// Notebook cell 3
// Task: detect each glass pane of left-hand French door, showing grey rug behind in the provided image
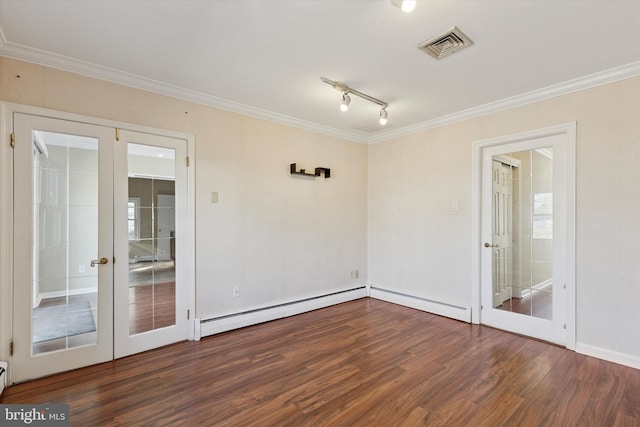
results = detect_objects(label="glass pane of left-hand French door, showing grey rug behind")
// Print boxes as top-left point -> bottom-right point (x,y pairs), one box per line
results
31,130 -> 99,354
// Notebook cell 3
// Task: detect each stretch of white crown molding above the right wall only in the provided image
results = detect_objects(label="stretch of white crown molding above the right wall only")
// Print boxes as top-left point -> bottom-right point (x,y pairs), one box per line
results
367,61 -> 640,144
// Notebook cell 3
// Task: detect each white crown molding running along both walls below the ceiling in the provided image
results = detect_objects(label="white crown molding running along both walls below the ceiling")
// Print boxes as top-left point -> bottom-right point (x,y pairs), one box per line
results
0,27 -> 640,144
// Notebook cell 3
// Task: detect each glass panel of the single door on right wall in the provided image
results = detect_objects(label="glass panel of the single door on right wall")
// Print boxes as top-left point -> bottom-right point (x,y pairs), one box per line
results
492,147 -> 553,320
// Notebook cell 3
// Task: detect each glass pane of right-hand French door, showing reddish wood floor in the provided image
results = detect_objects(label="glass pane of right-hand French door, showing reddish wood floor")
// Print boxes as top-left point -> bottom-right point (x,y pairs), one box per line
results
127,143 -> 176,335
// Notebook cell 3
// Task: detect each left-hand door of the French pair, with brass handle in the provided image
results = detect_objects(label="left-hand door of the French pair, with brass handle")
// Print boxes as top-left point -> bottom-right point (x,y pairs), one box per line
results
11,113 -> 114,382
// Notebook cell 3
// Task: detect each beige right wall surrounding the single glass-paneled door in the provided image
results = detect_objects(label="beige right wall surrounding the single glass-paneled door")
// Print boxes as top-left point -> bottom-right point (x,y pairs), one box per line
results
368,78 -> 640,364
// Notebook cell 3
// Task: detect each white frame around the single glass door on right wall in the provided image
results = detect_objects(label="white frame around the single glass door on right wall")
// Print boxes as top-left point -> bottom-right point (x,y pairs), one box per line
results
471,122 -> 576,350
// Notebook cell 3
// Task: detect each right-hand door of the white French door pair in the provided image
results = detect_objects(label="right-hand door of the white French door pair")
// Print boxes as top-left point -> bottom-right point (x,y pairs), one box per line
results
114,131 -> 189,358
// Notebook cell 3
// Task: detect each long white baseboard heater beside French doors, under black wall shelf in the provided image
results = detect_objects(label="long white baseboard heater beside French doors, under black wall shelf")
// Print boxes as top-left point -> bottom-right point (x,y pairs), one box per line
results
195,286 -> 367,340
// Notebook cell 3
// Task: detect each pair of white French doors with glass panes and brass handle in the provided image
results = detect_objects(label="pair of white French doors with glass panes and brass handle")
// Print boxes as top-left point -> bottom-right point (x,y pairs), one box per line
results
11,113 -> 188,382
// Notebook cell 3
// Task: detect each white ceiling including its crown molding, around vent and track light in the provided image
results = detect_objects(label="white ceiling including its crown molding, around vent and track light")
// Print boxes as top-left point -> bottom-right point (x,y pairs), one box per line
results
0,0 -> 640,142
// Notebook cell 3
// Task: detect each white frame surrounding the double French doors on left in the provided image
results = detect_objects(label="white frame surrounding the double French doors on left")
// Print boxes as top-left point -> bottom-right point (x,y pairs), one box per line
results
0,101 -> 196,380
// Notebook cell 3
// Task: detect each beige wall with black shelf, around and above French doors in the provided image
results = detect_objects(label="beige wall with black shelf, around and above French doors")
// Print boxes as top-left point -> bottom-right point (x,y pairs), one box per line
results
0,57 -> 367,318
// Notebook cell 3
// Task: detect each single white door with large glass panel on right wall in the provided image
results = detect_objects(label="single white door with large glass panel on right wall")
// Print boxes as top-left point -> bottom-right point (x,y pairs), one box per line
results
480,135 -> 569,345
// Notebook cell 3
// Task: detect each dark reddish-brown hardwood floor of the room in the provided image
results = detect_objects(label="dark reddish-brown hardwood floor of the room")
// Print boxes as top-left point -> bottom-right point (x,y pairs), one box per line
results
2,298 -> 640,427
